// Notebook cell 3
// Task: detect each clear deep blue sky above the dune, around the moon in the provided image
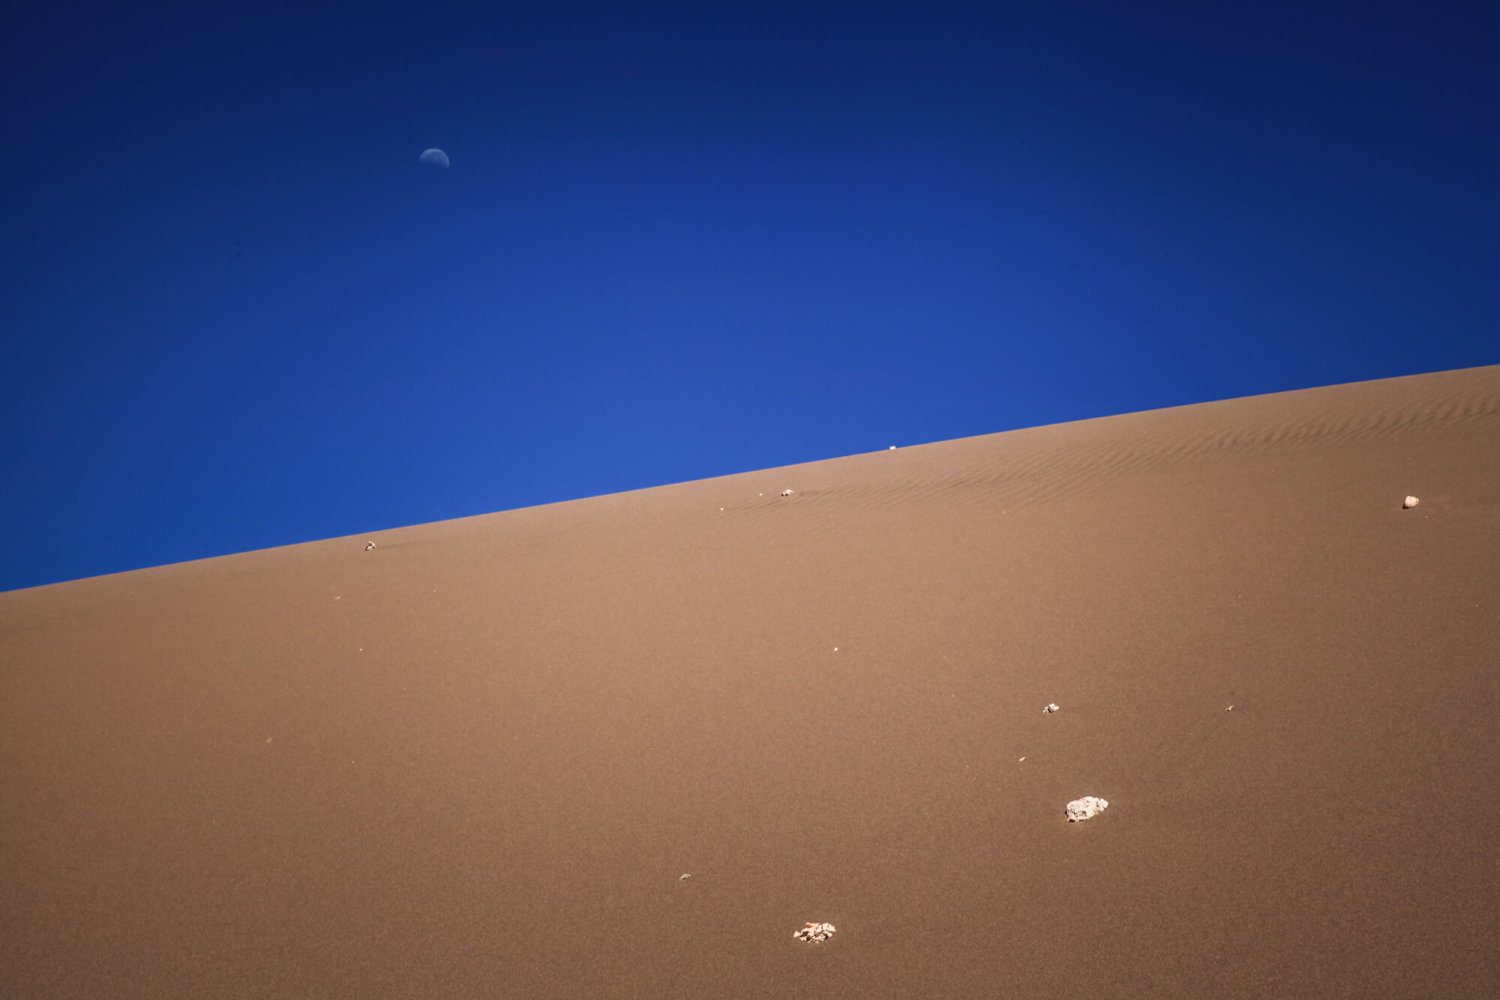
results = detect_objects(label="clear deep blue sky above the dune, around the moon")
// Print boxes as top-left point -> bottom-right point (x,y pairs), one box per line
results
0,0 -> 1500,589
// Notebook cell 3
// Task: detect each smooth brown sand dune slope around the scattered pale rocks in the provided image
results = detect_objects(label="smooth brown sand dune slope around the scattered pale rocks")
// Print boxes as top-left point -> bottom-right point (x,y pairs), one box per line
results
0,367 -> 1500,1000
